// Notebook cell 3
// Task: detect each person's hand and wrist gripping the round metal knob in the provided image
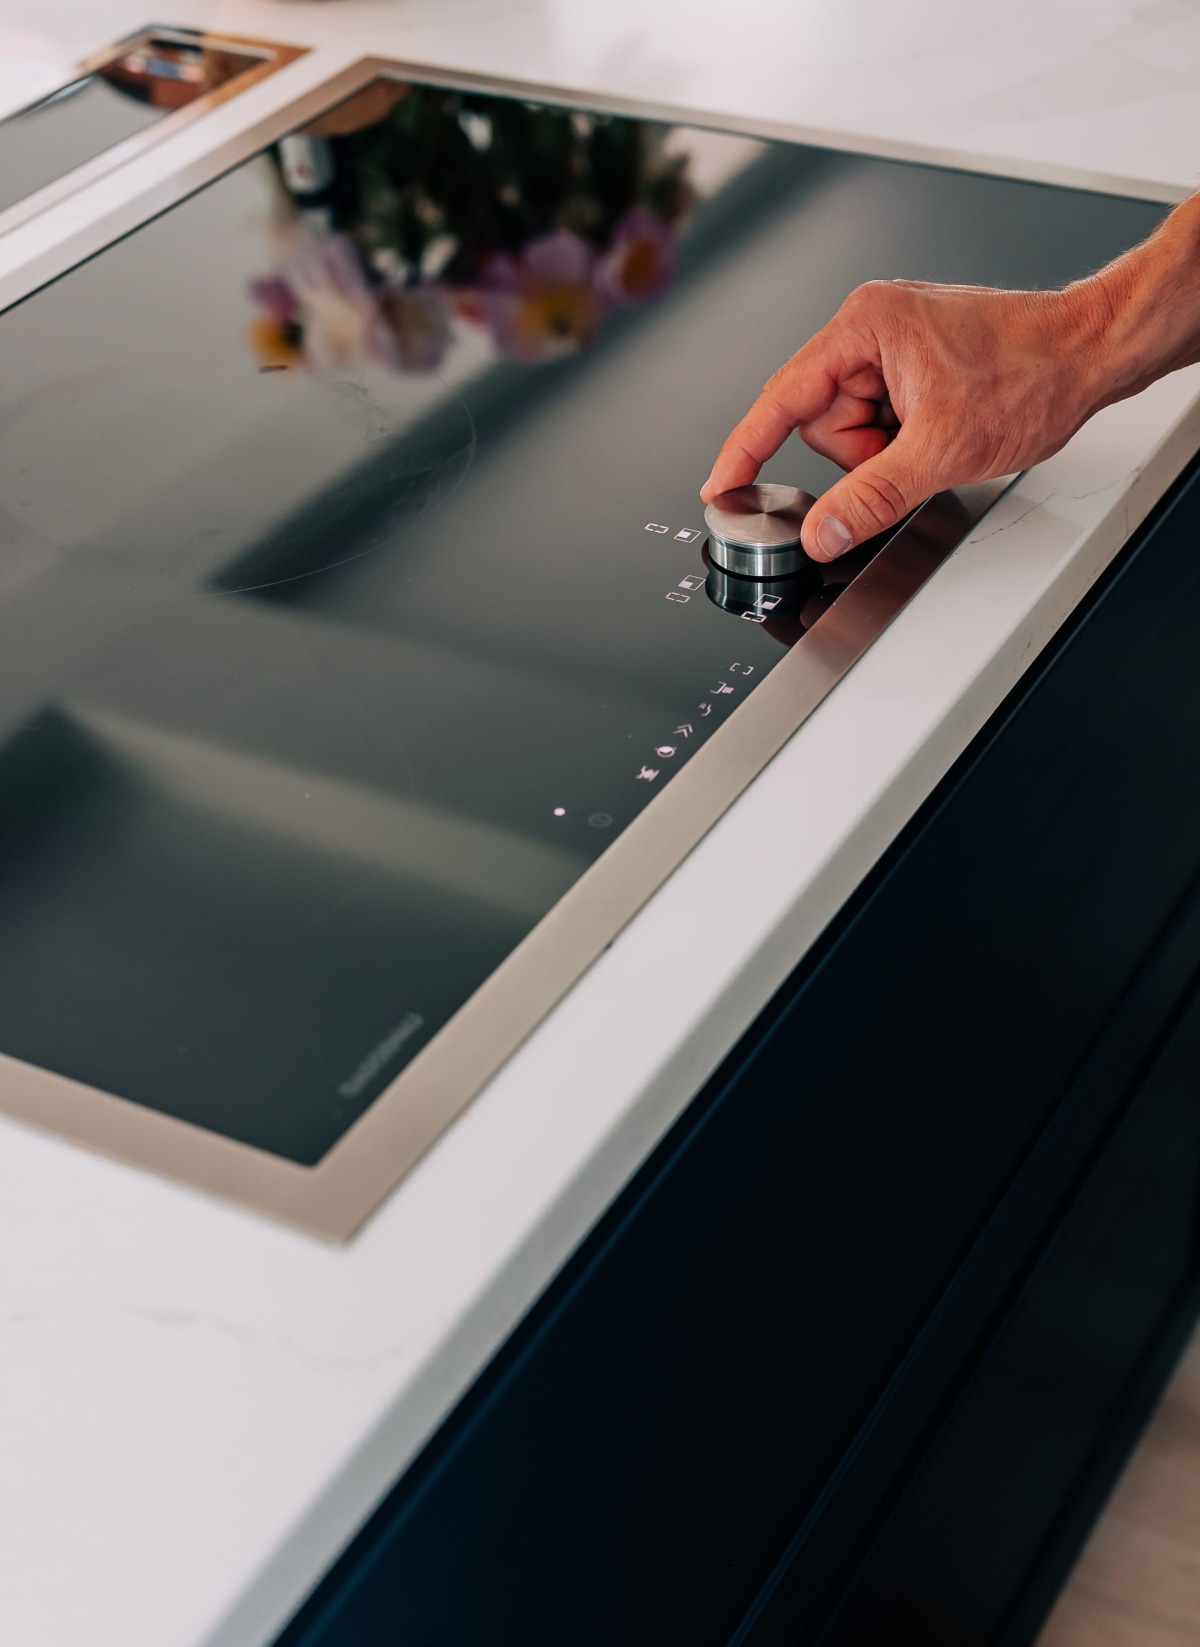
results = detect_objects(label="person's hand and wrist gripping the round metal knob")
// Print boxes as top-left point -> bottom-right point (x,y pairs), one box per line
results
700,196 -> 1200,560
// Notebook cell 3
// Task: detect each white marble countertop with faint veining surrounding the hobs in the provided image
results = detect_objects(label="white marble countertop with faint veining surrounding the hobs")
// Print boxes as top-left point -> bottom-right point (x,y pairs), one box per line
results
0,0 -> 1200,1647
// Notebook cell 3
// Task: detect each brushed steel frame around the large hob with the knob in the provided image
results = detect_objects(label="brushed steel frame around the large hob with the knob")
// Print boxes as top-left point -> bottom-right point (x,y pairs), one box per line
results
0,59 -> 1014,1240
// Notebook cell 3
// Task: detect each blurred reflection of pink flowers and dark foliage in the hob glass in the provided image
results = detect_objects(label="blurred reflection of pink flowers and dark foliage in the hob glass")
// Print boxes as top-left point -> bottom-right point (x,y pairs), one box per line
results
252,81 -> 695,372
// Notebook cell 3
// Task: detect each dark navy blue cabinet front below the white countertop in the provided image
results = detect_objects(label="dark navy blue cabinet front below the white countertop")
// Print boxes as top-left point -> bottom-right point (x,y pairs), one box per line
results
280,454 -> 1200,1647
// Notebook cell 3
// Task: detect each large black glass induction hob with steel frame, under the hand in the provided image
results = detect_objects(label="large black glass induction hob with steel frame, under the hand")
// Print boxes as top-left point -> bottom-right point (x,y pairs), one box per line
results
0,63 -> 1162,1237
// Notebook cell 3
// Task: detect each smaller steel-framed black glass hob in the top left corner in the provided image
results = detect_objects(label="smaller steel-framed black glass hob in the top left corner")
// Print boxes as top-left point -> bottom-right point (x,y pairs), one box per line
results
0,28 -> 303,232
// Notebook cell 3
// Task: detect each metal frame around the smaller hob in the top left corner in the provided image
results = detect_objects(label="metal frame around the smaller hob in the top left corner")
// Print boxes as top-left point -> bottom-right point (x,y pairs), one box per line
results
0,28 -> 309,236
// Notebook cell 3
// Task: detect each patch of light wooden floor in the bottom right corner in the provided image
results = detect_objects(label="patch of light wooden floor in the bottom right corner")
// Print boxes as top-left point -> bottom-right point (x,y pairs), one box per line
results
1037,1332 -> 1200,1647
